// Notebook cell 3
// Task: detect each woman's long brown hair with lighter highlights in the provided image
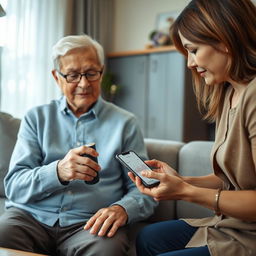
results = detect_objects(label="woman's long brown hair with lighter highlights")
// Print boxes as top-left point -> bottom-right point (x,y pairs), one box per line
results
171,0 -> 256,120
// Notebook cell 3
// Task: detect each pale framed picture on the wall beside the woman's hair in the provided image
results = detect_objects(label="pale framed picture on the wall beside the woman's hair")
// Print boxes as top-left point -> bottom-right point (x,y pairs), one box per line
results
156,11 -> 180,33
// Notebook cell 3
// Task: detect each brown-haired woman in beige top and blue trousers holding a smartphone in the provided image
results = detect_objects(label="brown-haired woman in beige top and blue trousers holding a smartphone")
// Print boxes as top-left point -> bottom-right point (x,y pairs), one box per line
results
129,0 -> 256,256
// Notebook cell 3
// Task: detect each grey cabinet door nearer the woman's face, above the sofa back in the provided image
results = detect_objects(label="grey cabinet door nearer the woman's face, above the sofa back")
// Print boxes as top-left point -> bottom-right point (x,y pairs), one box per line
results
147,52 -> 185,141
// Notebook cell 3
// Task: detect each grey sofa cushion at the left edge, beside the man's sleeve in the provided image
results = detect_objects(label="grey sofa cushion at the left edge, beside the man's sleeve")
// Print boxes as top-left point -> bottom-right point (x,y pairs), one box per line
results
0,112 -> 20,196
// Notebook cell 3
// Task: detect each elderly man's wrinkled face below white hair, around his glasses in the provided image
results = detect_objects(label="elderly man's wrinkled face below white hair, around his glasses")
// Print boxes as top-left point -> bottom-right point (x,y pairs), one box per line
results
53,47 -> 103,117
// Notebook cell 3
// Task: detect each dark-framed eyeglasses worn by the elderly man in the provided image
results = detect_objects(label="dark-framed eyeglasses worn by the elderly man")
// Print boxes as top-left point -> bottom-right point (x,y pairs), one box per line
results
57,70 -> 102,83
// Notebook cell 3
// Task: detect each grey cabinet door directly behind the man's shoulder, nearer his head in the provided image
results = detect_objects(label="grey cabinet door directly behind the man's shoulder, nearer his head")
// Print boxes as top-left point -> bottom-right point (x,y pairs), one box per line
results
108,55 -> 148,136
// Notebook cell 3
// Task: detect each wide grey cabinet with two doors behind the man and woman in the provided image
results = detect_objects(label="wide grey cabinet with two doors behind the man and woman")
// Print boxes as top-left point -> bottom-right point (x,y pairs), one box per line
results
107,50 -> 209,142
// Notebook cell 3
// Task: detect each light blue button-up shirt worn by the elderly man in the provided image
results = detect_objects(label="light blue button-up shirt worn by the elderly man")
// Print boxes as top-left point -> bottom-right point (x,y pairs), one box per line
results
4,97 -> 157,226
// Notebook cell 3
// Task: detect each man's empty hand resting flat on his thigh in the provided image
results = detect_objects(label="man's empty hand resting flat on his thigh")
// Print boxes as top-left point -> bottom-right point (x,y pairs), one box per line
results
84,205 -> 128,237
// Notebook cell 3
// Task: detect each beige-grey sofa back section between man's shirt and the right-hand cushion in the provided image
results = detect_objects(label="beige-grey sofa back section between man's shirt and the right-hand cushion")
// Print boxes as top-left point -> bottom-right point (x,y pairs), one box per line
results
144,138 -> 184,222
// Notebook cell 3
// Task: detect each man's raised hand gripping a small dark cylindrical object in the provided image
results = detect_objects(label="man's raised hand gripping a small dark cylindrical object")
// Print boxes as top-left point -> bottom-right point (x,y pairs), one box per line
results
57,146 -> 101,182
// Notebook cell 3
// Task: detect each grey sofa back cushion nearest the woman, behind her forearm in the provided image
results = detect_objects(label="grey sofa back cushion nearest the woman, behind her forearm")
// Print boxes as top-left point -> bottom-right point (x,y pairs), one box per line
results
177,141 -> 213,218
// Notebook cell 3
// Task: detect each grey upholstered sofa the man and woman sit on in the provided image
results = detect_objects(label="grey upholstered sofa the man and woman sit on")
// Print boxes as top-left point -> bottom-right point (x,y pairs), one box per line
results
0,112 -> 213,256
